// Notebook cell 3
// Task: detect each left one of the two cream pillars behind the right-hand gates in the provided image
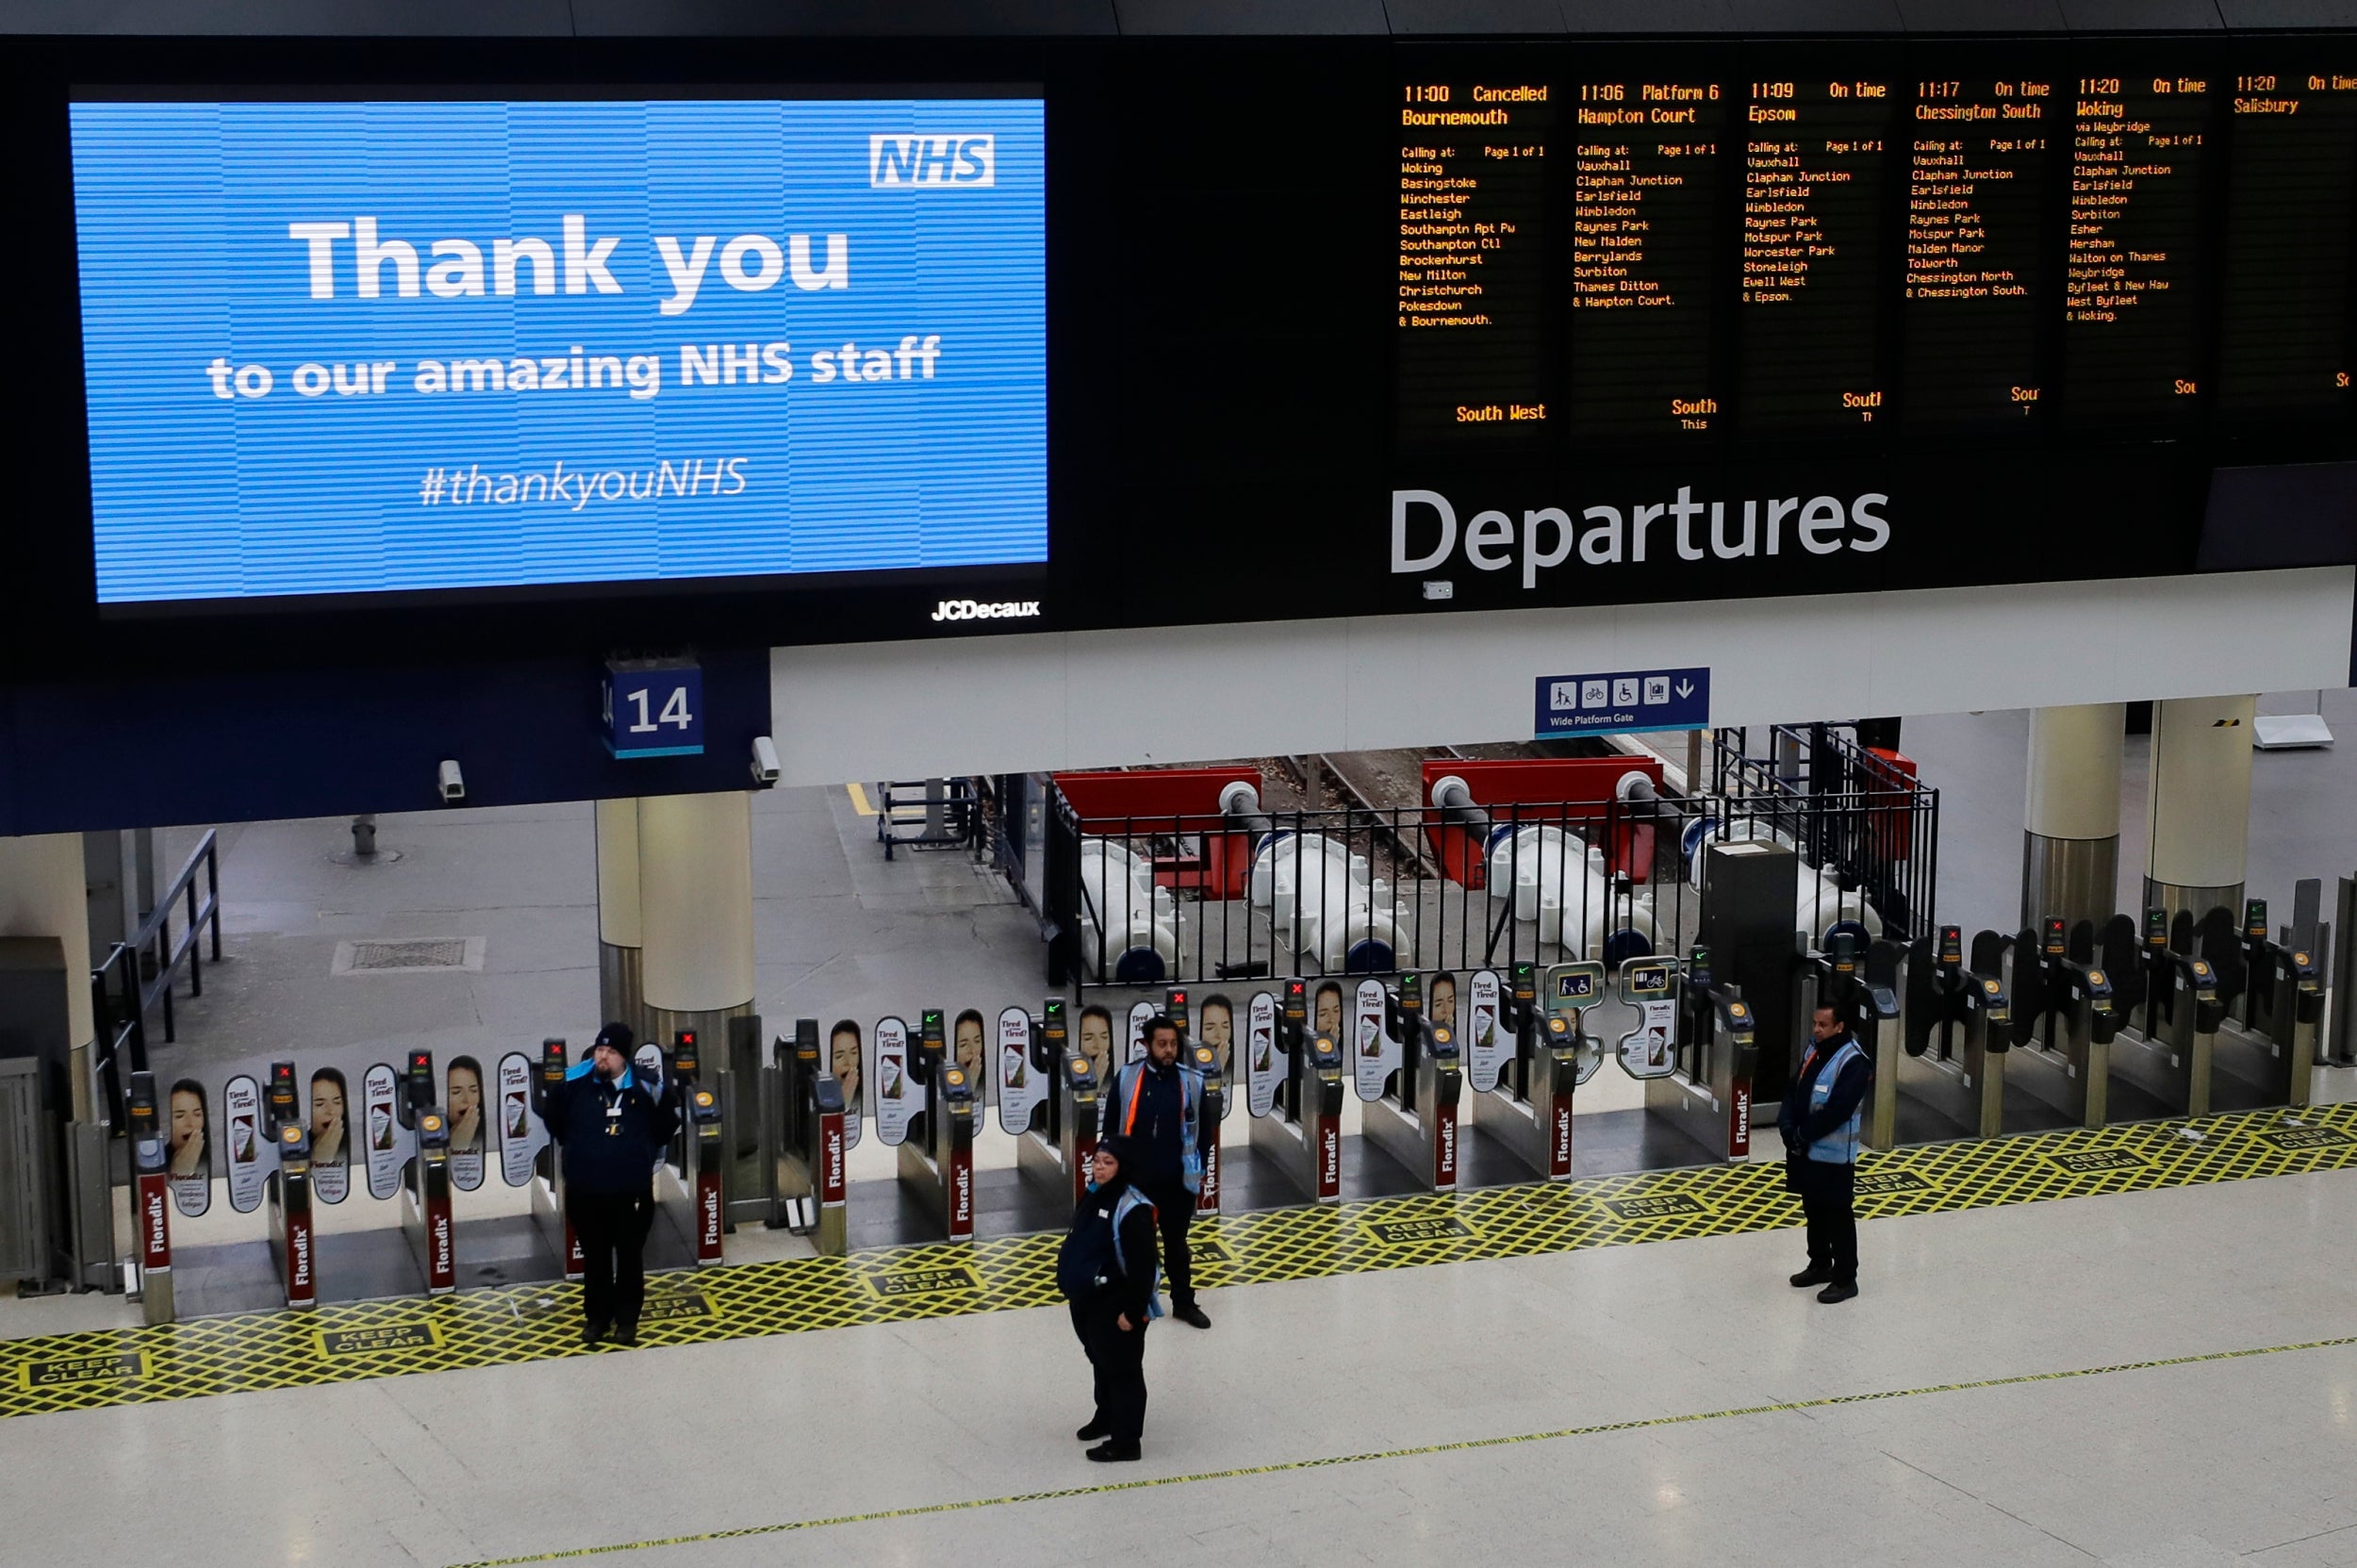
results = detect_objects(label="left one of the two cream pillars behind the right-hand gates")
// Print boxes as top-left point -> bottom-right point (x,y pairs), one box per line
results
2022,702 -> 2129,929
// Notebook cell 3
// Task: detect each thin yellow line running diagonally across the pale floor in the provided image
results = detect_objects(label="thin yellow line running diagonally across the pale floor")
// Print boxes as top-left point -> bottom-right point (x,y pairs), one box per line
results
438,1334 -> 2357,1568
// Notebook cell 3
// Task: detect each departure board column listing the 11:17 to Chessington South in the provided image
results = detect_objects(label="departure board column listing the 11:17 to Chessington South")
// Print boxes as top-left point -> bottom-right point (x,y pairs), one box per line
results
1900,75 -> 2063,429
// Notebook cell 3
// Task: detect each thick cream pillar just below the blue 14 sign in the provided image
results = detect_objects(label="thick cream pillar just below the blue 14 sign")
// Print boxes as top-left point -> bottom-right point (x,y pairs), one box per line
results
639,792 -> 752,1061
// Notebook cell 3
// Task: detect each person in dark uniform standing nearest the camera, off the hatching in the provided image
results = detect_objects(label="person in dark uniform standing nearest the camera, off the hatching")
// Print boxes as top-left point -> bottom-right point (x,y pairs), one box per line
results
1056,1136 -> 1162,1464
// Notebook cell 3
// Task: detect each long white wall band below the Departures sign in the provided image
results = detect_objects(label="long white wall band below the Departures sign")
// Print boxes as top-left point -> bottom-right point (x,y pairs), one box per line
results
771,566 -> 2357,783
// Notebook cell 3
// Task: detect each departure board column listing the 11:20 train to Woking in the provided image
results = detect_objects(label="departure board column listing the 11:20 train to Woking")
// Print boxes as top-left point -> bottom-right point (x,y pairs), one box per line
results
2063,74 -> 2211,429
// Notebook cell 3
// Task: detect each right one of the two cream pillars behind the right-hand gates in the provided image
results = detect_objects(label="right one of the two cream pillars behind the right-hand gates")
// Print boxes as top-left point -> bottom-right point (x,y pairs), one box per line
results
2145,698 -> 2258,924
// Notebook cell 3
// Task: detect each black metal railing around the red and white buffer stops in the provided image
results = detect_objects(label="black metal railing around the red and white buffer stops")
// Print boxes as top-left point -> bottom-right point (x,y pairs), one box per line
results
1045,787 -> 1937,990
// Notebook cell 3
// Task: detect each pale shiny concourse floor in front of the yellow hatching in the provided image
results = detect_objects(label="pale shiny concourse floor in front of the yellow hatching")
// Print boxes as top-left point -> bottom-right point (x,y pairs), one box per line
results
13,1172 -> 2357,1568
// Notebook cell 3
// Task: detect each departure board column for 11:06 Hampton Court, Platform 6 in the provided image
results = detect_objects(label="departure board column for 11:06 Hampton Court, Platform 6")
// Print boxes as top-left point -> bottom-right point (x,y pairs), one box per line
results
1570,80 -> 1730,438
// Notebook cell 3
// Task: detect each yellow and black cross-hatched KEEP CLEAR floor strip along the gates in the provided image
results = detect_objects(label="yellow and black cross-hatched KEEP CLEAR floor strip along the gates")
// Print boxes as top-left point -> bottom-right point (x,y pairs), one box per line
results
0,1103 -> 2357,1414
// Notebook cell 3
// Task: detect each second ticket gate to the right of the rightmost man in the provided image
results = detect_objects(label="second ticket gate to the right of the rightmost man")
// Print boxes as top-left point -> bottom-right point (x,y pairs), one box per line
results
1973,917 -> 2131,1127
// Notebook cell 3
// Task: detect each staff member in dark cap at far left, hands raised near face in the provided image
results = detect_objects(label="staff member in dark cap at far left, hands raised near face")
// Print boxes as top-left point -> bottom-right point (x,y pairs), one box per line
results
547,1023 -> 679,1344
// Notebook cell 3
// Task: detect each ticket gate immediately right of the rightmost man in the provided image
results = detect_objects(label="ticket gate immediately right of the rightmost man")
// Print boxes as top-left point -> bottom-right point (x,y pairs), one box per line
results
1867,927 -> 2013,1148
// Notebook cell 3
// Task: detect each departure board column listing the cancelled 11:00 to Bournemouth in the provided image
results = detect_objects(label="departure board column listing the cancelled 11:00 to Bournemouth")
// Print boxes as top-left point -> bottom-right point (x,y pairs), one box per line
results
1395,75 -> 1554,441
